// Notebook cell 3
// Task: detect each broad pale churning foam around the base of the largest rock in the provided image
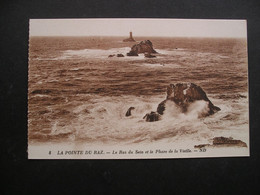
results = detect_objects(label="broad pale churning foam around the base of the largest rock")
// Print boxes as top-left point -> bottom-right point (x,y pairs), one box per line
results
46,91 -> 249,148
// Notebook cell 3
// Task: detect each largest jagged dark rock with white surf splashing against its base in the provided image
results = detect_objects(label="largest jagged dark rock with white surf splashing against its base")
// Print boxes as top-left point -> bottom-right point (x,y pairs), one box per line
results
157,83 -> 220,117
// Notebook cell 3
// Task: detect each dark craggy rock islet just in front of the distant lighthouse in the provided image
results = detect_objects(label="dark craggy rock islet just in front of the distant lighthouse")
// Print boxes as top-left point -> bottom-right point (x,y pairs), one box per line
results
126,40 -> 157,56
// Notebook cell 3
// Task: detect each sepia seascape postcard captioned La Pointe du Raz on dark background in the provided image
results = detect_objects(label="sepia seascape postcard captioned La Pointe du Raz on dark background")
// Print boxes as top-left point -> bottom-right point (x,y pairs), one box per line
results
28,19 -> 249,159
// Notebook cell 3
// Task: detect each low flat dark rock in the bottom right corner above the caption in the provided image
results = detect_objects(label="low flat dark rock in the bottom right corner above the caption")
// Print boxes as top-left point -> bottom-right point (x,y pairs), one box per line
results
194,137 -> 247,148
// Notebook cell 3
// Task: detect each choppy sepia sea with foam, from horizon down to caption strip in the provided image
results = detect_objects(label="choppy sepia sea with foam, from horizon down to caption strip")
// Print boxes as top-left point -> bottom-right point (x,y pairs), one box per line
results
28,37 -> 248,144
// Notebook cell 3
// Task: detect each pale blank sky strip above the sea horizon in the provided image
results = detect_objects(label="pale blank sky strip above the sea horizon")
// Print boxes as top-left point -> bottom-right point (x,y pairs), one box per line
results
30,19 -> 247,38
